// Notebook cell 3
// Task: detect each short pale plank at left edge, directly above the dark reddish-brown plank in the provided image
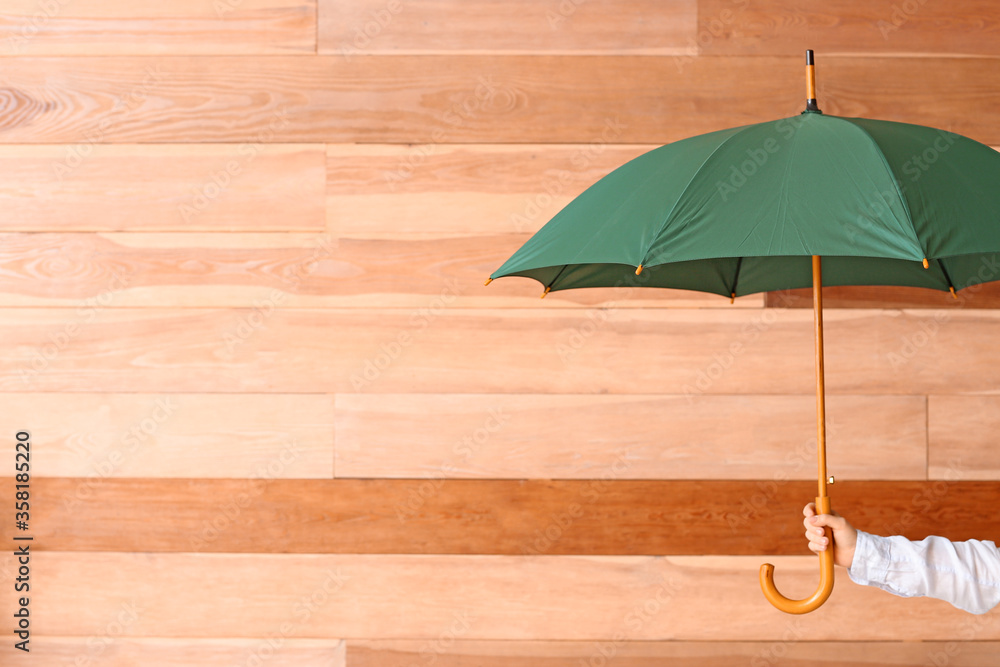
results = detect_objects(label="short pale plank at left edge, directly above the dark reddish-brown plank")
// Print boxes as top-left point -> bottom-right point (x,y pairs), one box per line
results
0,393 -> 334,478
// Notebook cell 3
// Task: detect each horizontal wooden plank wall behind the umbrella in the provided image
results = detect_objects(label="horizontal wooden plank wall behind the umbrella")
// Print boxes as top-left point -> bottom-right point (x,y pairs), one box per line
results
0,0 -> 1000,667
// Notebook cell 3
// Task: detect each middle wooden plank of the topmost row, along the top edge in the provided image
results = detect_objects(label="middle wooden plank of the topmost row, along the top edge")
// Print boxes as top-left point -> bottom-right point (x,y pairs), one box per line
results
319,0 -> 697,57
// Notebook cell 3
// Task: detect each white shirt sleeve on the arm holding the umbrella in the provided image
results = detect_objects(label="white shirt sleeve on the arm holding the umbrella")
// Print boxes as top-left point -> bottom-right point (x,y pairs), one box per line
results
847,530 -> 1000,614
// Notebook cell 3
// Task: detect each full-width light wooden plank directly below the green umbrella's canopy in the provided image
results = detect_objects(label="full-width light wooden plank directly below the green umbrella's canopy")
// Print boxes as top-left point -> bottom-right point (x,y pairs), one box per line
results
0,308 -> 1000,396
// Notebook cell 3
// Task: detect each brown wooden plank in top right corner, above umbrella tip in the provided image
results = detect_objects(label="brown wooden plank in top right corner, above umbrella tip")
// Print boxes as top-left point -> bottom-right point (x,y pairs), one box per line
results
697,0 -> 1000,56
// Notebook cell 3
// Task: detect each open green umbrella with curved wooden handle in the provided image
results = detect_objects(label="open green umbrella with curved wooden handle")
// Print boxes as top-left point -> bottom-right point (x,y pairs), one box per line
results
487,51 -> 1000,613
